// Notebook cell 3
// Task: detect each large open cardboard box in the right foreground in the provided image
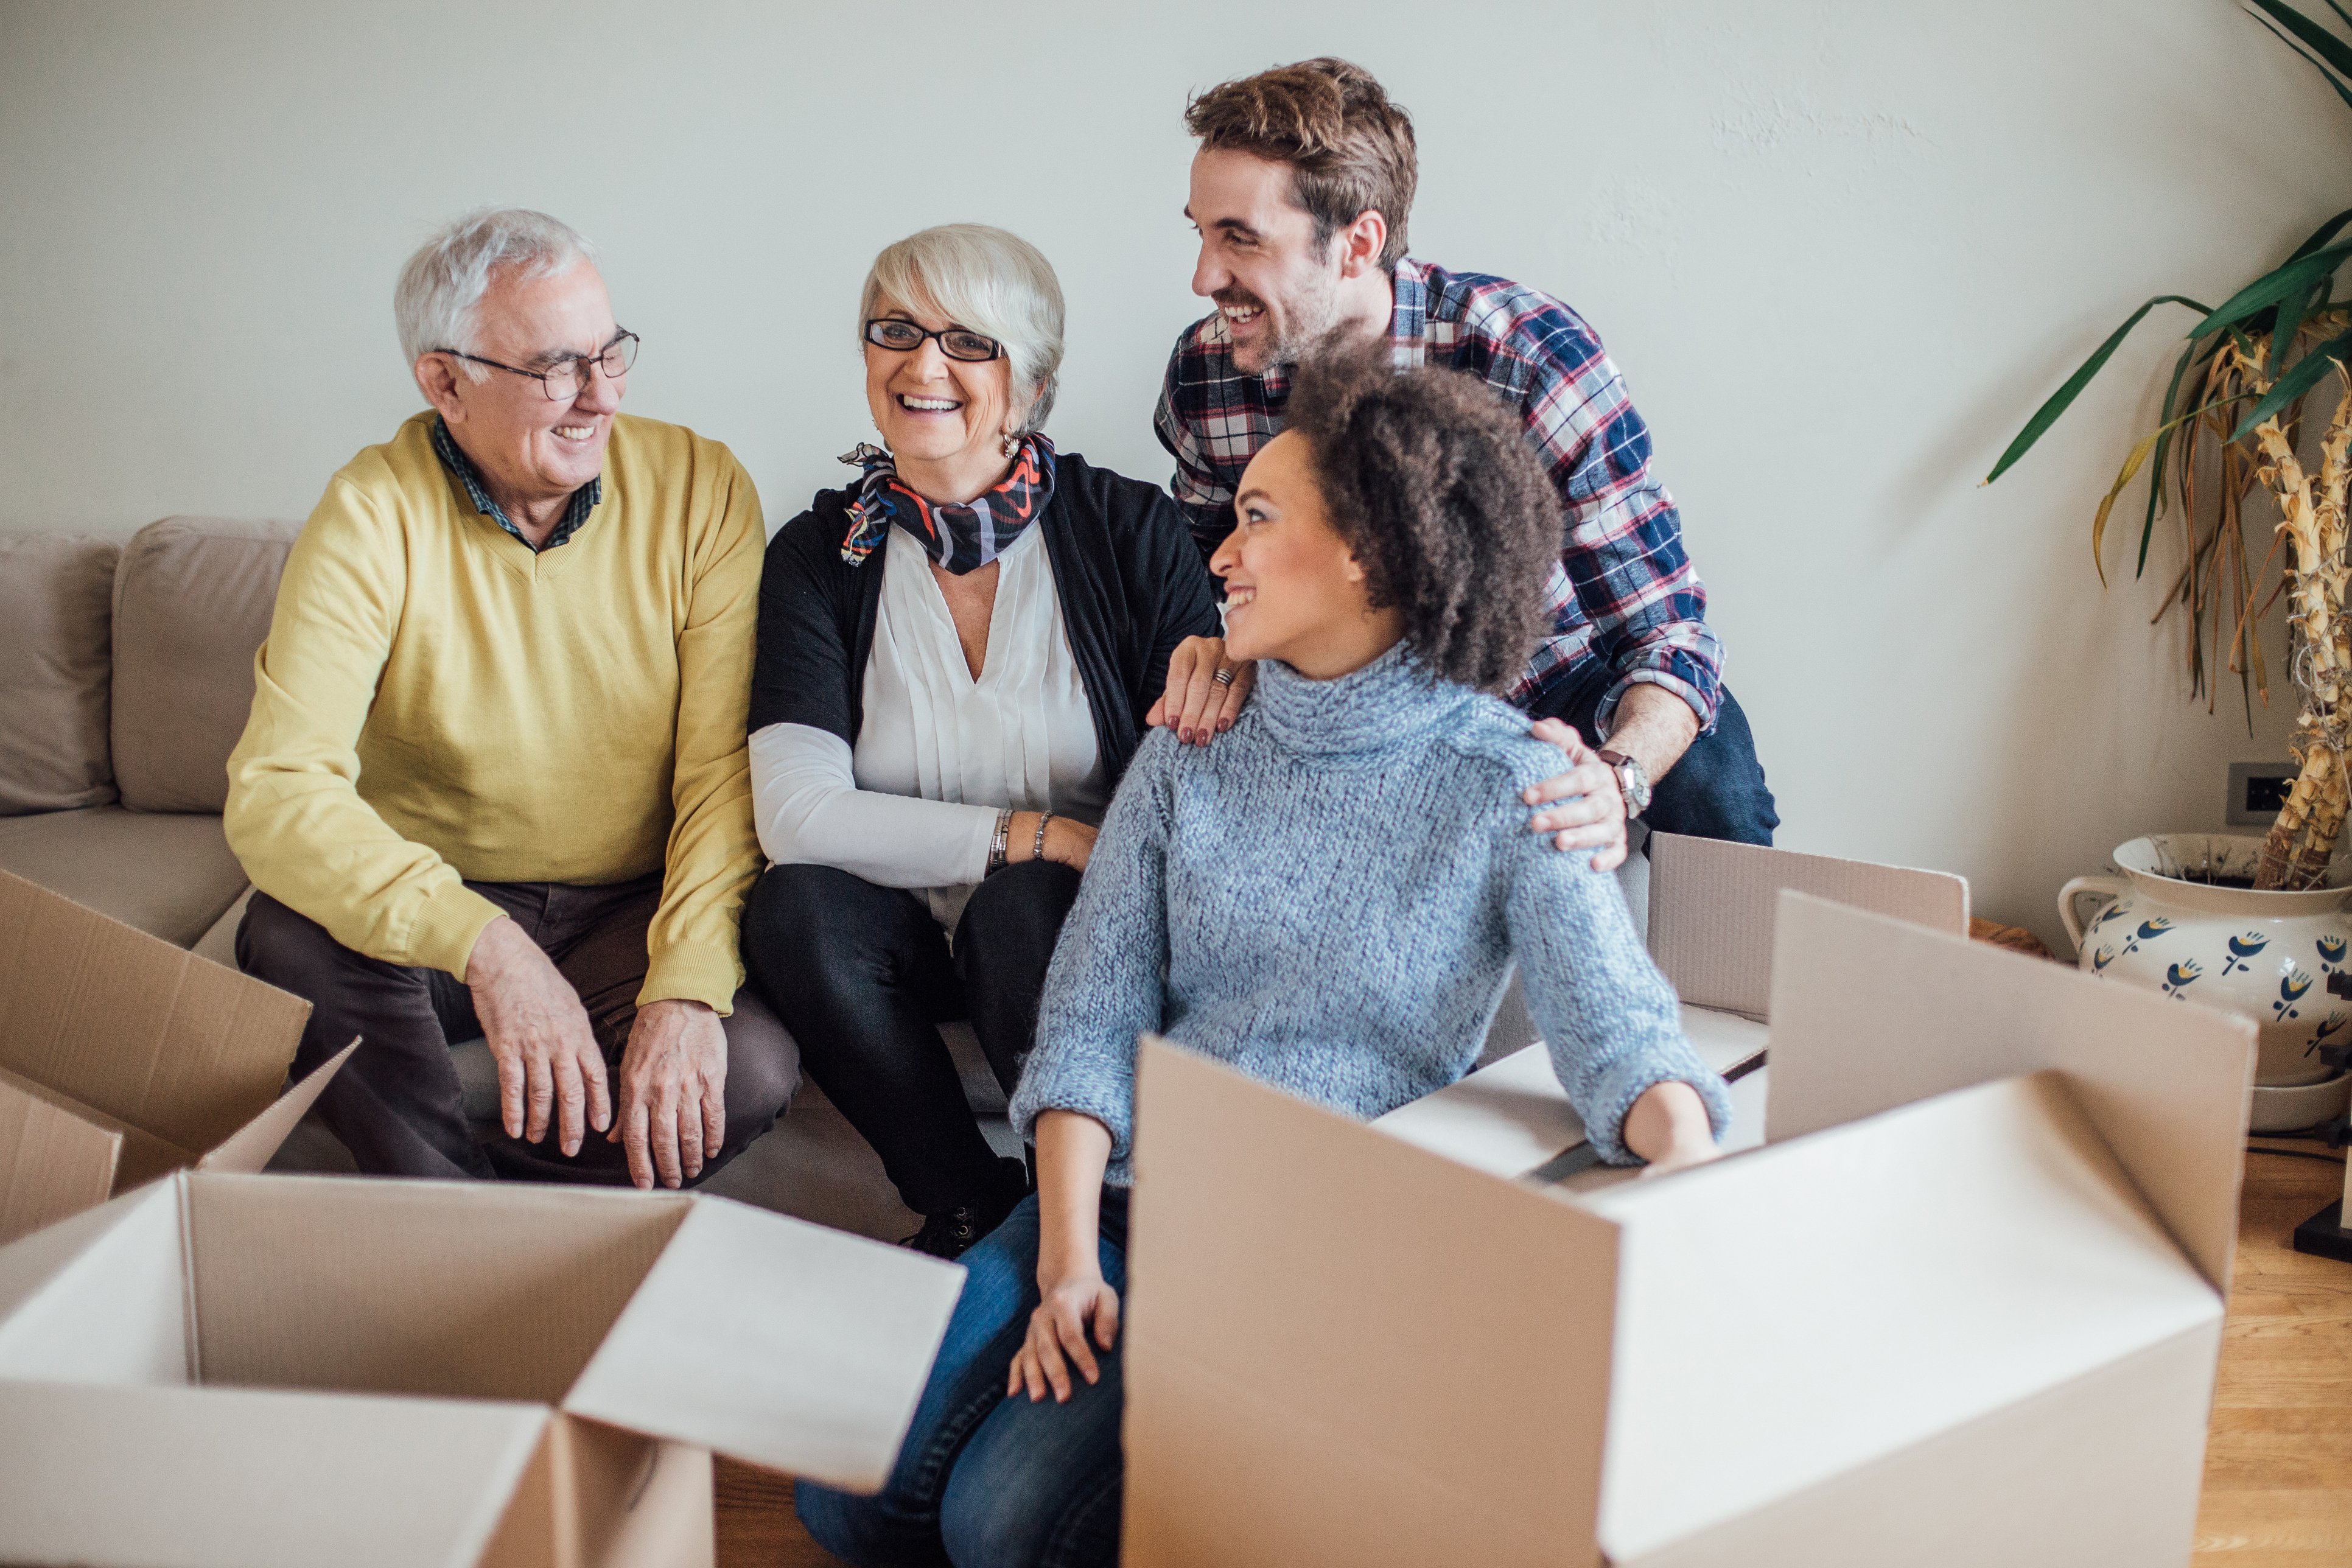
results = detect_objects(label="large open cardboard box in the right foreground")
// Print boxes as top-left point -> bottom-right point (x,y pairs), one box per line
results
1124,894 -> 2253,1568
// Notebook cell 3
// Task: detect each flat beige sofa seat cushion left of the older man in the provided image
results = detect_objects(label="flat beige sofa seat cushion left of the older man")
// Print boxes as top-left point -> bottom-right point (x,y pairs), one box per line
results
0,807 -> 245,947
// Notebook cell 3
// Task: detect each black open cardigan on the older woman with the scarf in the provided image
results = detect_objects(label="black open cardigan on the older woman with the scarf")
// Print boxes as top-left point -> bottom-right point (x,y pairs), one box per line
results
751,453 -> 1219,785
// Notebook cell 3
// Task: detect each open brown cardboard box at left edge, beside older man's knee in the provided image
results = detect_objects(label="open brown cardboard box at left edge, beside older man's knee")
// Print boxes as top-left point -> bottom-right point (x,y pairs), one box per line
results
0,872 -> 351,1241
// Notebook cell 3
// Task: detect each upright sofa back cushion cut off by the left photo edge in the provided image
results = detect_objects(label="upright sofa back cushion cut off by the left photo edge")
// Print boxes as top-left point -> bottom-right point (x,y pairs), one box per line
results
0,534 -> 122,816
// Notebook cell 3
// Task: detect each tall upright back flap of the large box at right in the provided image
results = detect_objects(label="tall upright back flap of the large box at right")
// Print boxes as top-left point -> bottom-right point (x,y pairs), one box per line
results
1766,894 -> 2256,1293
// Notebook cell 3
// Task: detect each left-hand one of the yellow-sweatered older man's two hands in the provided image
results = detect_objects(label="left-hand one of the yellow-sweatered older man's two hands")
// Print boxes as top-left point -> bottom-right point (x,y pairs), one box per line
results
466,914 -> 612,1154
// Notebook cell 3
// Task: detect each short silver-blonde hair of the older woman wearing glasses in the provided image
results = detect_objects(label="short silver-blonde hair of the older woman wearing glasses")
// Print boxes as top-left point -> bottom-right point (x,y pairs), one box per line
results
858,223 -> 1061,435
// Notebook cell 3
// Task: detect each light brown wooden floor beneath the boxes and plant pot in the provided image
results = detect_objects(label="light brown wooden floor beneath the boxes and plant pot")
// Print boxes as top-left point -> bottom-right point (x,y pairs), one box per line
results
718,1145 -> 2352,1568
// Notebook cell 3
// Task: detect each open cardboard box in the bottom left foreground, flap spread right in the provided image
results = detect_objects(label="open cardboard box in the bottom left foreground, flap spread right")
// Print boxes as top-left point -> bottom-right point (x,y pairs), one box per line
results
0,1173 -> 962,1568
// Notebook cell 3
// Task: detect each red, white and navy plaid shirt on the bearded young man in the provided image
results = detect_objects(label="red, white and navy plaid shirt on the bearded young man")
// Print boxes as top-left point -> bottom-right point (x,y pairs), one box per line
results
1155,259 -> 1724,733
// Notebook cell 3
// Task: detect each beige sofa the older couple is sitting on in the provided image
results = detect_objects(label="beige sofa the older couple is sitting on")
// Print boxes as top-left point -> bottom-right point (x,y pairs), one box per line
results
0,517 -> 997,1236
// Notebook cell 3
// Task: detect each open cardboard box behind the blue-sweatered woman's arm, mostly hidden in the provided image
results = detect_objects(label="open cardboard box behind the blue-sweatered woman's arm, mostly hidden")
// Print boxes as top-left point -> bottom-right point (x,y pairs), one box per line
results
1374,832 -> 1969,1178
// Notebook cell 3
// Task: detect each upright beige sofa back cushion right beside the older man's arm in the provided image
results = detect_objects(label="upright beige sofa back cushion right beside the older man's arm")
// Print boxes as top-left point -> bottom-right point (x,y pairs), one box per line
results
113,517 -> 301,811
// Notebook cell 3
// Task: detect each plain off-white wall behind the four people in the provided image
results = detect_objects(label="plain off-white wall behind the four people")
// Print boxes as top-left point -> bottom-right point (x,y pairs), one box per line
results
0,0 -> 2352,933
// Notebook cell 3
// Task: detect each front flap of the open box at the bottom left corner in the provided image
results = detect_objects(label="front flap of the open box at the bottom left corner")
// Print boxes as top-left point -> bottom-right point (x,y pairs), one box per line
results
0,1385 -> 550,1568
